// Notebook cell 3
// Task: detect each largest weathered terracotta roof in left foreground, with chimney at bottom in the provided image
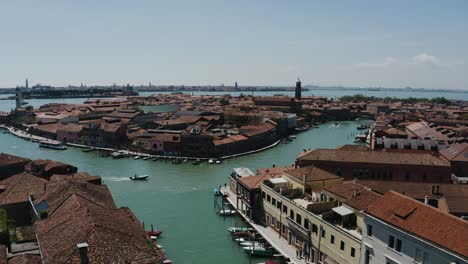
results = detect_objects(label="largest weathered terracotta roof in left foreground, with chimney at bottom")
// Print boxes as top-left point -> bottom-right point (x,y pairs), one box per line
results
34,195 -> 164,264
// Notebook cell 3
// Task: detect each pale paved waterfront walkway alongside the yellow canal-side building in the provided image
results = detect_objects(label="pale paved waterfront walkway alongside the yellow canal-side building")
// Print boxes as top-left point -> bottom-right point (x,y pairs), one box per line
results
221,187 -> 308,264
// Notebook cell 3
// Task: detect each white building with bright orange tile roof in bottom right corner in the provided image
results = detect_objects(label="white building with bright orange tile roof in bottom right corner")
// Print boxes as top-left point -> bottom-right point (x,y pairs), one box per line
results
361,191 -> 468,264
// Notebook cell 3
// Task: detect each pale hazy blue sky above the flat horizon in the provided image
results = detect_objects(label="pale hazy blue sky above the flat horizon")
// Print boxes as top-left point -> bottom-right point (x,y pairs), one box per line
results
0,0 -> 468,90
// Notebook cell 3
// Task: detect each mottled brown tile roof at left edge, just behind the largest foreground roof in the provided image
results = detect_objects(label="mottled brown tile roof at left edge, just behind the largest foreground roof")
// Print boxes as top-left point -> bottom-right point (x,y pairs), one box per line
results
0,173 -> 47,205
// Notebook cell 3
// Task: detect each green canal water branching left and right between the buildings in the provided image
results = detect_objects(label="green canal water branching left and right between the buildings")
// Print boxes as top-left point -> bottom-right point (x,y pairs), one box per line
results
0,121 -> 368,264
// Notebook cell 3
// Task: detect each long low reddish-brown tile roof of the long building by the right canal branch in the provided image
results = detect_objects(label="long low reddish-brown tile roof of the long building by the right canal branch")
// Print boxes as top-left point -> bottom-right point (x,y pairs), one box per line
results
299,149 -> 450,167
